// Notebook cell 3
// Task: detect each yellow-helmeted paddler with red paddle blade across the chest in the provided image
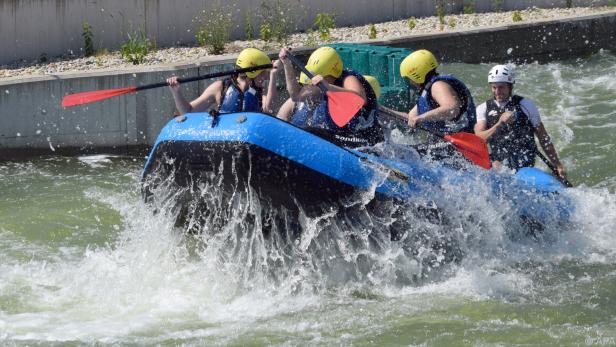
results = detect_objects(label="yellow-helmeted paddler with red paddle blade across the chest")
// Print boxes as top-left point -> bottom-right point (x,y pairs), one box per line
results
278,47 -> 384,147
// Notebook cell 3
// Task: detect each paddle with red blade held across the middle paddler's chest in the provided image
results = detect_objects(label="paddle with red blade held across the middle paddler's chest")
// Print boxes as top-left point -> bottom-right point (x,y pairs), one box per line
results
288,53 -> 365,128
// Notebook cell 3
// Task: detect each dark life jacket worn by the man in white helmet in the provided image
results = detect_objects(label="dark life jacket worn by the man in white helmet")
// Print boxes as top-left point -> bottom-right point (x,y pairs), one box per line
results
485,95 -> 537,170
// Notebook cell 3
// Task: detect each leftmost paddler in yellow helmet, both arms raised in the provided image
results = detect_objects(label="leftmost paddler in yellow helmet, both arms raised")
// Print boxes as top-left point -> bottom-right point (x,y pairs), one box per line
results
167,48 -> 281,114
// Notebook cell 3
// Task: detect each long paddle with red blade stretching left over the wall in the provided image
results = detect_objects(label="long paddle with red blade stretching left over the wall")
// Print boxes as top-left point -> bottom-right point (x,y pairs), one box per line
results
62,64 -> 272,107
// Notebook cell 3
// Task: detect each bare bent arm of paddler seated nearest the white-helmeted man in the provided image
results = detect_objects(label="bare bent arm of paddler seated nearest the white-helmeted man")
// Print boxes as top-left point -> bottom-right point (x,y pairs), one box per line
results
409,81 -> 462,127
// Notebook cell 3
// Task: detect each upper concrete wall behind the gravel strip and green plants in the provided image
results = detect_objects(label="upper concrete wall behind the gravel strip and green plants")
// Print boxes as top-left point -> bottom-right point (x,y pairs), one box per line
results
0,0 -> 609,64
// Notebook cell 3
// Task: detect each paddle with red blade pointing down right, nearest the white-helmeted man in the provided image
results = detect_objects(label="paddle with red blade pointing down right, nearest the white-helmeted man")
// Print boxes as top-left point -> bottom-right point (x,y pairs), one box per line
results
379,107 -> 492,170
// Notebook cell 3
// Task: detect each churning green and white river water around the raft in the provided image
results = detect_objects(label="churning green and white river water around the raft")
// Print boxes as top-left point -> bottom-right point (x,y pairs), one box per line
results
0,52 -> 616,346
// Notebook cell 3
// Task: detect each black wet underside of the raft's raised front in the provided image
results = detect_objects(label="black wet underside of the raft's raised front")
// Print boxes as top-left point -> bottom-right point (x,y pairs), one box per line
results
144,141 -> 368,215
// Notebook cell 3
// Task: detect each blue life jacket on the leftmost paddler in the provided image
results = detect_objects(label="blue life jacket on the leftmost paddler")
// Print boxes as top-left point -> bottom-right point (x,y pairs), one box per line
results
218,78 -> 263,113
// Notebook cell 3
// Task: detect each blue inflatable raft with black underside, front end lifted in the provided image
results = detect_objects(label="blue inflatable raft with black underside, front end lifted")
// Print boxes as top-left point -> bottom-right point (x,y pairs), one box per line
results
142,112 -> 573,230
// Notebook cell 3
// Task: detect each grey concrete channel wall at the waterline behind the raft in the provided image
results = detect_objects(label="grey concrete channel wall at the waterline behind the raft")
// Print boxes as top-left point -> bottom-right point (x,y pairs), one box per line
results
0,11 -> 616,160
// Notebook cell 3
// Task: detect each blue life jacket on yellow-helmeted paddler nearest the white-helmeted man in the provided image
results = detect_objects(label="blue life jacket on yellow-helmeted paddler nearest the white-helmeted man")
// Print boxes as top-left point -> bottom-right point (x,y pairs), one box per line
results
417,75 -> 477,134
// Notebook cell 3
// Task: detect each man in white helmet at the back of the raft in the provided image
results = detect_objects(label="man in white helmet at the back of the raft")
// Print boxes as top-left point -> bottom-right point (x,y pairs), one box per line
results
475,65 -> 566,180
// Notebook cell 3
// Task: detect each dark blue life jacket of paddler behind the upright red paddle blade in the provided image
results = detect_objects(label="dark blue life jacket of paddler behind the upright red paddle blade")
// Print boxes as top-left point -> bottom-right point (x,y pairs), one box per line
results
291,70 -> 384,147
